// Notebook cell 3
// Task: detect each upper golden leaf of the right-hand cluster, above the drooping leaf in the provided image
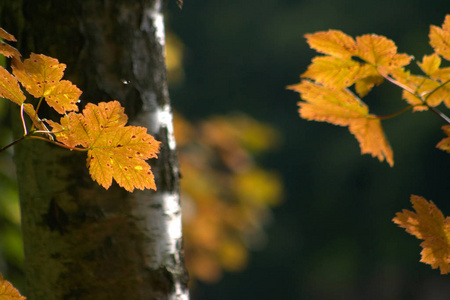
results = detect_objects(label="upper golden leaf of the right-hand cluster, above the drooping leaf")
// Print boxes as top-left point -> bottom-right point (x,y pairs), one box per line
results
301,30 -> 412,97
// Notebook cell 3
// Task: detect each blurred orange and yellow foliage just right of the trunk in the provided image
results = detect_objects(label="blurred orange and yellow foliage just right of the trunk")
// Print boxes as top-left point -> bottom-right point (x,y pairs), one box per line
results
174,114 -> 283,281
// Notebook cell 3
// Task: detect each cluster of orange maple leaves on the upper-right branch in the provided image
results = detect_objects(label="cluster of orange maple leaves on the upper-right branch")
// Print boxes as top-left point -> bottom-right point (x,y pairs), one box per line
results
288,15 -> 450,166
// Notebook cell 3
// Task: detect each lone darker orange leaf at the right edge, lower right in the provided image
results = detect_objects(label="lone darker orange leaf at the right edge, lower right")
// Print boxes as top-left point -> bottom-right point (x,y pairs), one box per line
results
392,195 -> 450,274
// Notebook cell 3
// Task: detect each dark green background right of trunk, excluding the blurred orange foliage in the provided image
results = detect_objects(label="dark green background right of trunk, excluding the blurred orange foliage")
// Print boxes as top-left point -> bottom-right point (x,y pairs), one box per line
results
167,0 -> 450,300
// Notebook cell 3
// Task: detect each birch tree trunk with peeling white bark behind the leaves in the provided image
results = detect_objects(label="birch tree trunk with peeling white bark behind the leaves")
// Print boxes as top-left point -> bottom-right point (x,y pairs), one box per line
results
1,0 -> 188,300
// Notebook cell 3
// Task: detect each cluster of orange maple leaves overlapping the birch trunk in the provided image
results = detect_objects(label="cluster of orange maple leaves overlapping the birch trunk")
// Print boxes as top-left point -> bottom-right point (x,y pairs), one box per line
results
0,28 -> 160,192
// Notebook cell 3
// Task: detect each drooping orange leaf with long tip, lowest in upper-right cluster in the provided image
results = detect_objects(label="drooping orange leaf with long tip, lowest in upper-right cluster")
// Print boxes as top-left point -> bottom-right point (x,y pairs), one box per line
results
288,80 -> 394,166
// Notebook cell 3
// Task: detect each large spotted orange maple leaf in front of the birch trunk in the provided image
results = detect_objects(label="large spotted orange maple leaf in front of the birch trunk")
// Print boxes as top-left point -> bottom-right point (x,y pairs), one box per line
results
47,101 -> 160,192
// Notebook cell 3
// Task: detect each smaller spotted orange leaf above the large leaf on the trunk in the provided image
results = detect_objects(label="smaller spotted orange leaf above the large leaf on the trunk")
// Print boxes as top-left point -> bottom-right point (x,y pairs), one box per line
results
12,53 -> 81,114
